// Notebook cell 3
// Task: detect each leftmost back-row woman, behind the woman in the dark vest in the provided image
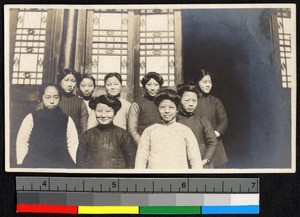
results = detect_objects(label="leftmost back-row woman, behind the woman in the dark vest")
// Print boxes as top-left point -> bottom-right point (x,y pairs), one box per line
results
57,69 -> 88,135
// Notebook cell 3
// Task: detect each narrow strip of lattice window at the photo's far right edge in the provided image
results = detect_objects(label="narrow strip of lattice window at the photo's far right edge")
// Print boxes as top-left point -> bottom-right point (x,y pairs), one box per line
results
277,9 -> 293,88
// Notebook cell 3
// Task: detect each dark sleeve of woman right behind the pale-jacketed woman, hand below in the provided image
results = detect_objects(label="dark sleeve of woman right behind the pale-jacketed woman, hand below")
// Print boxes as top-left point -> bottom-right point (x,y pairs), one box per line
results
201,118 -> 218,160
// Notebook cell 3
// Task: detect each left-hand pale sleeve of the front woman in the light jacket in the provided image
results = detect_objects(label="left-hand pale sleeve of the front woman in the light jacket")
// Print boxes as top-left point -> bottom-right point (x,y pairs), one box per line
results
135,129 -> 150,169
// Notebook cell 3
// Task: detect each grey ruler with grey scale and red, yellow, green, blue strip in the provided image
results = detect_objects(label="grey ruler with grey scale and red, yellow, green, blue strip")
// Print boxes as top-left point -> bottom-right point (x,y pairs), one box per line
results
16,177 -> 259,214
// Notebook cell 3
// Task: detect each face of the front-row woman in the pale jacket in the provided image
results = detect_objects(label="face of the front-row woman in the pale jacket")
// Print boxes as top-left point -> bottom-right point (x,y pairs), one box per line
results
158,99 -> 177,123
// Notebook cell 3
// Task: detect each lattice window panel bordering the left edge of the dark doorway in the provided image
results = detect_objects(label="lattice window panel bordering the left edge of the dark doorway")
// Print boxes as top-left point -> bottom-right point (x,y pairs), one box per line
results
140,9 -> 175,86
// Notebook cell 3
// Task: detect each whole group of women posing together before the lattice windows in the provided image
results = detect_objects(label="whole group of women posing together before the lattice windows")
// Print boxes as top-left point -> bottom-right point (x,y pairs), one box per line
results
16,69 -> 227,169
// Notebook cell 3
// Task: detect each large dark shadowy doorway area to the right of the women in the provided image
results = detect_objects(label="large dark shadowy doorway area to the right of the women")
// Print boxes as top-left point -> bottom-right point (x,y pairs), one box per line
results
182,9 -> 291,168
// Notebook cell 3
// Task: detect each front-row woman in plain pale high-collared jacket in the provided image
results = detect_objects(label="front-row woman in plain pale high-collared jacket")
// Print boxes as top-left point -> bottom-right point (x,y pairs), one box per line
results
135,89 -> 203,169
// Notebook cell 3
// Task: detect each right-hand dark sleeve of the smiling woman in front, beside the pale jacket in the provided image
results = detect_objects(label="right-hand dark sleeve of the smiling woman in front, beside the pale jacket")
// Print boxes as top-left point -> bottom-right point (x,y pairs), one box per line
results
121,131 -> 136,169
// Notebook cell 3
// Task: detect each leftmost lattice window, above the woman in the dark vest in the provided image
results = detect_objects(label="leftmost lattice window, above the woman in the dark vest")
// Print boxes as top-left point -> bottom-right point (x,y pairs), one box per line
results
12,9 -> 47,85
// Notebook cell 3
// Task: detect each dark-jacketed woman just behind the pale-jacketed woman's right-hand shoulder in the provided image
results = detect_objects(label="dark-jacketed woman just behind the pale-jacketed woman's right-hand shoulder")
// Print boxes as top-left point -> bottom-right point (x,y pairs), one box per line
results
177,85 -> 218,168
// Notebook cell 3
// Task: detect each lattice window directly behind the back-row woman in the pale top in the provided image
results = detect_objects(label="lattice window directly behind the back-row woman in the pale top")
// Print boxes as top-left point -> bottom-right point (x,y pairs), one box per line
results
92,10 -> 128,86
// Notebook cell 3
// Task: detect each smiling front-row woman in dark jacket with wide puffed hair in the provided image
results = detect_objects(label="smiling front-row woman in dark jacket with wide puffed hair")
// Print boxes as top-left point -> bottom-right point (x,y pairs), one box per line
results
77,95 -> 136,169
